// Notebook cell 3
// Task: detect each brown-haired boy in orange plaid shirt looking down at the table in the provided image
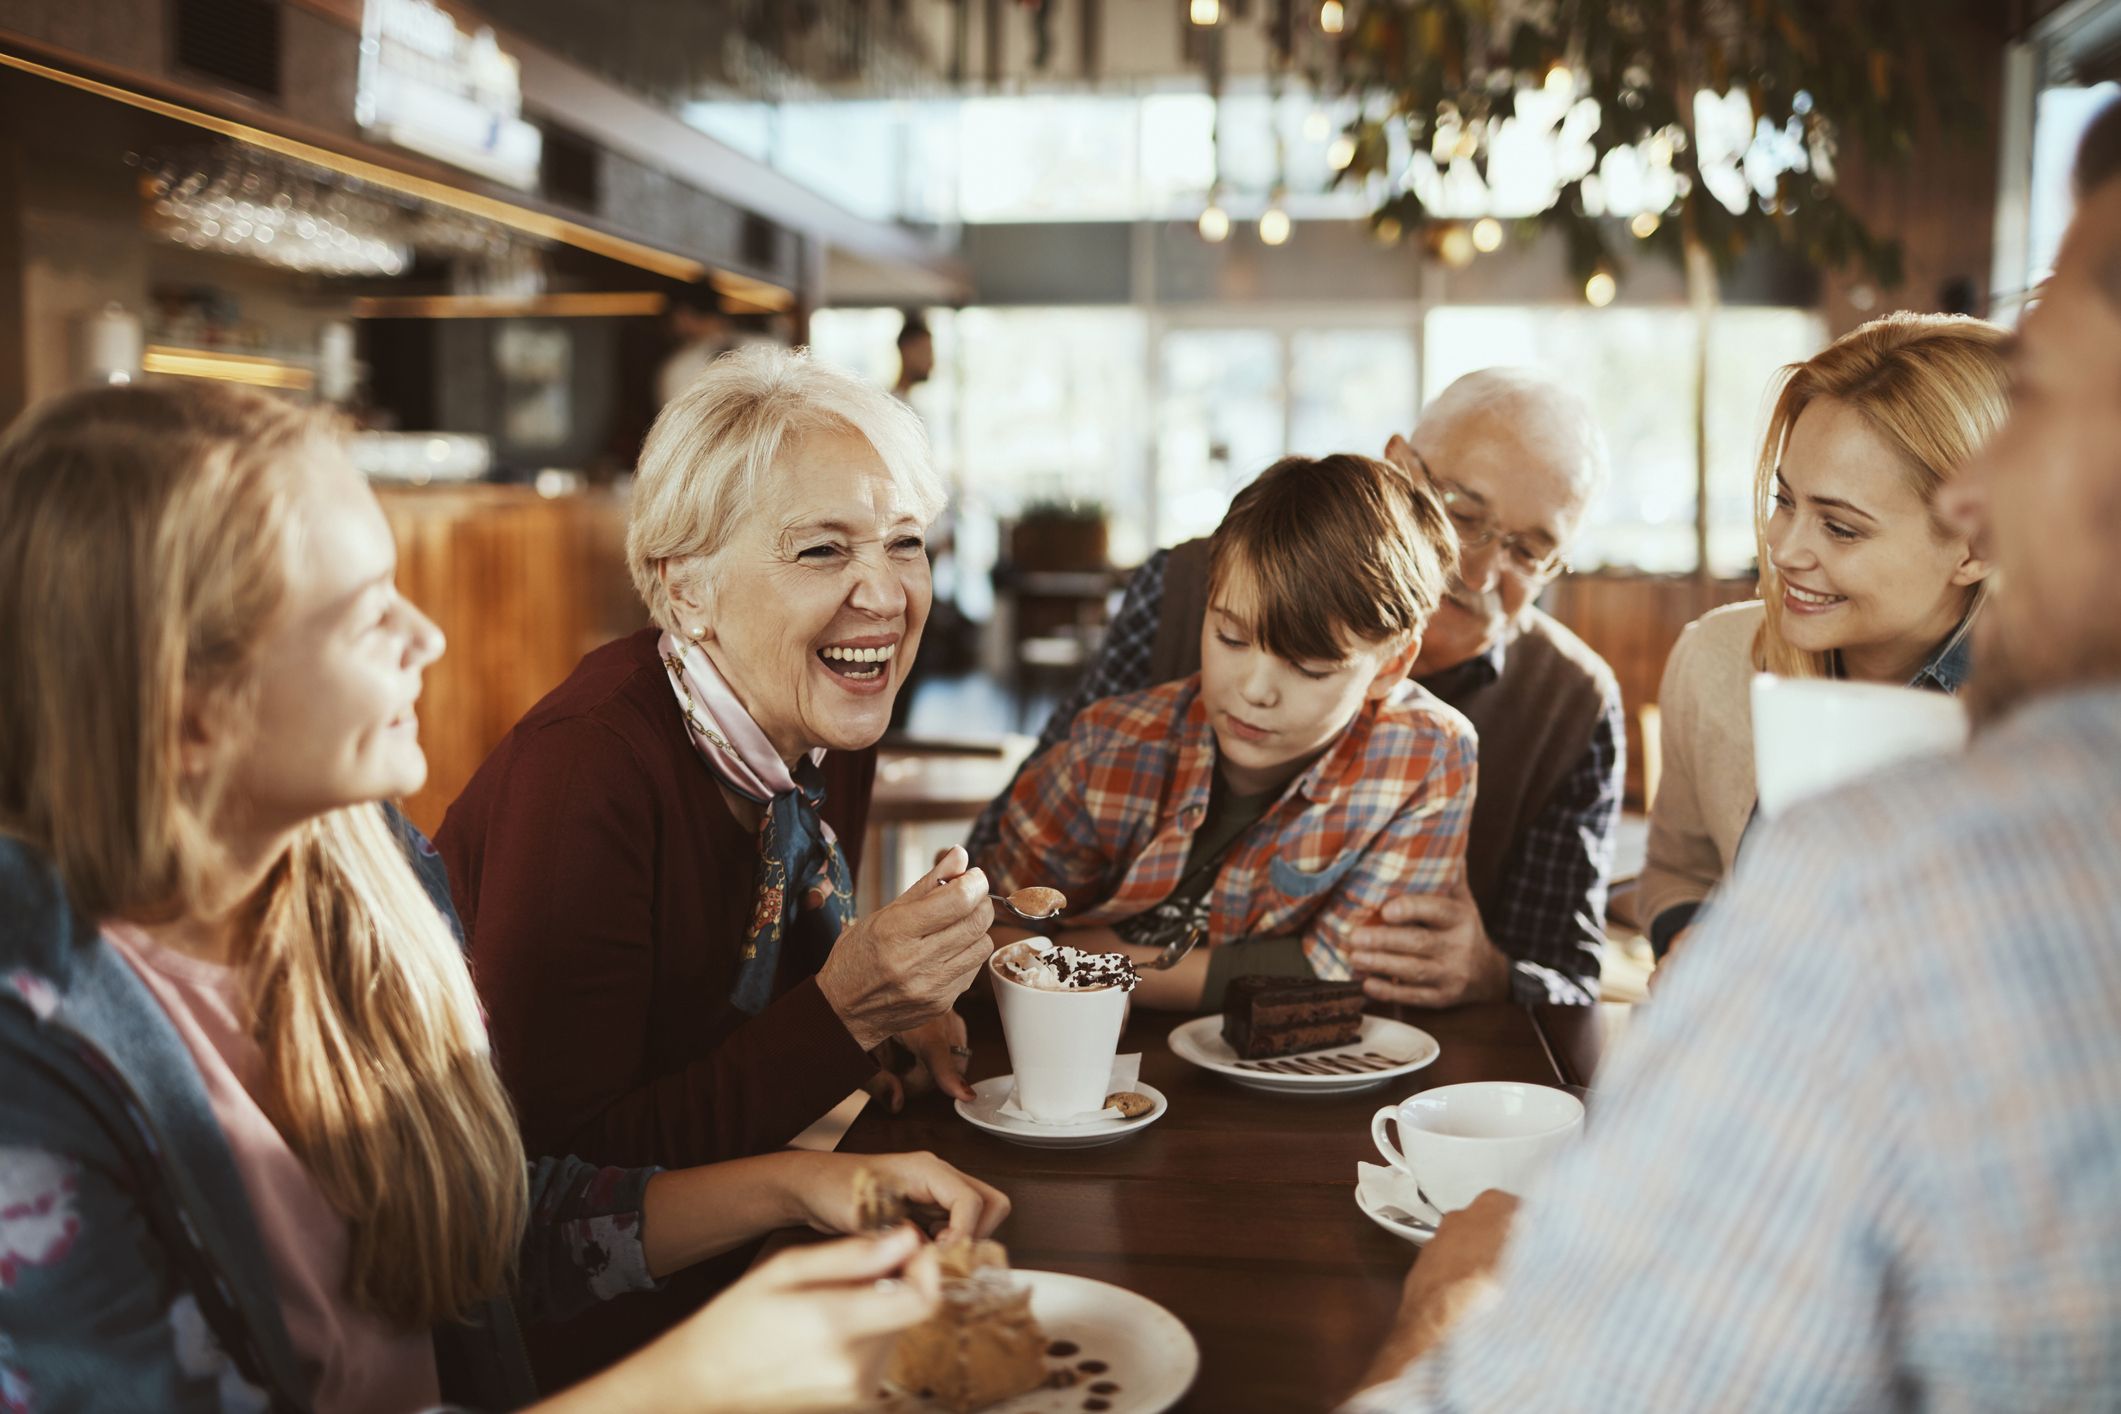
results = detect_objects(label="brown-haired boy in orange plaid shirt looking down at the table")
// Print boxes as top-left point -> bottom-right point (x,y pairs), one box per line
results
978,454 -> 1474,1009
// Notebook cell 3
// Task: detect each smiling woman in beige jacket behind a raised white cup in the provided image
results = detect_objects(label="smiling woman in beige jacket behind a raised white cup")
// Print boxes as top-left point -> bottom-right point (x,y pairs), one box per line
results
1642,314 -> 2009,954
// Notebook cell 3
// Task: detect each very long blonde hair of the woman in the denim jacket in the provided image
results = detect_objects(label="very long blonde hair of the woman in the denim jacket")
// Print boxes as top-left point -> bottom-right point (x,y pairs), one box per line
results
0,386 -> 528,1327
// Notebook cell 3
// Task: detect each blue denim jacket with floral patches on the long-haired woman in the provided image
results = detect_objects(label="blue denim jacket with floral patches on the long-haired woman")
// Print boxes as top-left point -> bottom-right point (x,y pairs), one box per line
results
0,812 -> 655,1410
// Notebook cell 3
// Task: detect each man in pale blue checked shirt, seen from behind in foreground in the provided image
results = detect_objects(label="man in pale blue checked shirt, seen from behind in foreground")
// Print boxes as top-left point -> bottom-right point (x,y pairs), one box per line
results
1349,106 -> 2121,1414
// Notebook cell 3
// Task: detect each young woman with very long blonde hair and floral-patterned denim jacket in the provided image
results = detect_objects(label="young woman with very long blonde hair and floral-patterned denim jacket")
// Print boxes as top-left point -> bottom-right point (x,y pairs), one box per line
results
0,388 -> 1007,1414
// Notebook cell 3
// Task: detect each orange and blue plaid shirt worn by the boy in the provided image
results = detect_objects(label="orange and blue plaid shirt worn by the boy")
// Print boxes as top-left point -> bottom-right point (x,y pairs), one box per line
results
980,674 -> 1476,982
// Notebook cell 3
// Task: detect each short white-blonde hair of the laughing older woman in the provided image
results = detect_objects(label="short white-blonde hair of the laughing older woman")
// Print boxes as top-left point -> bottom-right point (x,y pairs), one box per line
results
626,346 -> 944,638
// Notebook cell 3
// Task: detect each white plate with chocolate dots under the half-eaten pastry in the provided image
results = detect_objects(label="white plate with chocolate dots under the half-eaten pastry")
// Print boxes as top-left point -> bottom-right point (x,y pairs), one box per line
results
884,1272 -> 1200,1414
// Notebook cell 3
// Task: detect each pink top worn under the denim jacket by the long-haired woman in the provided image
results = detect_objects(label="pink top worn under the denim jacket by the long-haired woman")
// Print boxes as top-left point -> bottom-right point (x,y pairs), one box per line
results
104,922 -> 441,1414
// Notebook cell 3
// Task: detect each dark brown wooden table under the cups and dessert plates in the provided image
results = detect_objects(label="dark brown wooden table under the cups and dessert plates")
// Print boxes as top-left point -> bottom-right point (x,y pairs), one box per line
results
840,996 -> 1597,1414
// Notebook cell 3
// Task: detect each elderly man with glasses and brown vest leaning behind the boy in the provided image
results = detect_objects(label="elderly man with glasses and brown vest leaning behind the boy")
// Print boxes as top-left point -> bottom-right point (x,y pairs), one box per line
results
969,369 -> 1627,1007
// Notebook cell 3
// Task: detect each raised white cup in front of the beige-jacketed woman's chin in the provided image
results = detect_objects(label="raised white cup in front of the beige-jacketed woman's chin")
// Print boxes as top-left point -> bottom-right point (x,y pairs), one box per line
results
1752,672 -> 1966,818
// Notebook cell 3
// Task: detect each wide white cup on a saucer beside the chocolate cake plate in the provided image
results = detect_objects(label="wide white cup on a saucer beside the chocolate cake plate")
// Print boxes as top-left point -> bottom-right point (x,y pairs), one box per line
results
1370,1081 -> 1584,1213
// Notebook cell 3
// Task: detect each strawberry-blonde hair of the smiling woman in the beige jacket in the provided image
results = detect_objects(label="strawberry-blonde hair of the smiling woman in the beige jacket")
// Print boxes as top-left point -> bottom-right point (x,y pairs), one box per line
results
1752,312 -> 2011,678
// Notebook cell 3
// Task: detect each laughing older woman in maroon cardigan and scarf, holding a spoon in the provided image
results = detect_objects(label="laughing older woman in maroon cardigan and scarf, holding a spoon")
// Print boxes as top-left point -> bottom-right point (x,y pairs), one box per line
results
437,348 -> 993,1376
